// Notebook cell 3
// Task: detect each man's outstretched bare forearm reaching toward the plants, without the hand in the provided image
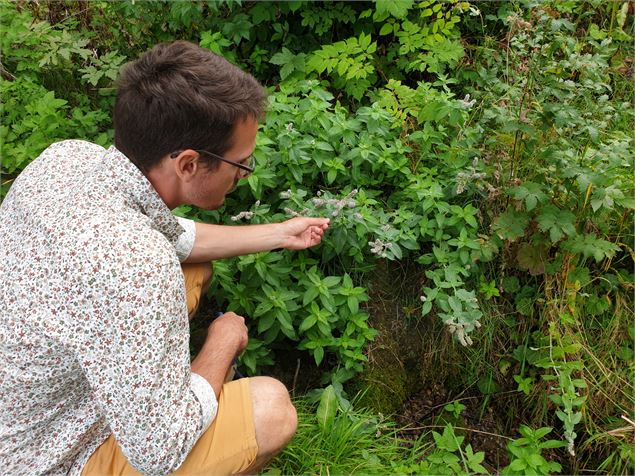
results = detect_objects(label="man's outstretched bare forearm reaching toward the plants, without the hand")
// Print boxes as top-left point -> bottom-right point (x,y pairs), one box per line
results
185,223 -> 284,263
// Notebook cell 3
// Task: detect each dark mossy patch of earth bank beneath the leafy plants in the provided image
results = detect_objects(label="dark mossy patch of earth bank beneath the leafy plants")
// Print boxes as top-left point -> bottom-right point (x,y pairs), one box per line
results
347,261 -> 472,414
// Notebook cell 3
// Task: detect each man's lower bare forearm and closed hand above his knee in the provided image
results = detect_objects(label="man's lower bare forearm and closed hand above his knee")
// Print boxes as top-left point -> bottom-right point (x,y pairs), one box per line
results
192,312 -> 248,398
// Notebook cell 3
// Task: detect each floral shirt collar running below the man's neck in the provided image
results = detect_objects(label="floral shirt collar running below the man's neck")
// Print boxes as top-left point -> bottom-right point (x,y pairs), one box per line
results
103,145 -> 185,245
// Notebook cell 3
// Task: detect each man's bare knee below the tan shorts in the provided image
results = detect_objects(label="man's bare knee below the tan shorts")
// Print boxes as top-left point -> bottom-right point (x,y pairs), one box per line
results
250,377 -> 298,453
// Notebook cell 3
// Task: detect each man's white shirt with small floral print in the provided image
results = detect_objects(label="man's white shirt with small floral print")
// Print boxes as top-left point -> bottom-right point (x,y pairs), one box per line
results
0,141 -> 217,475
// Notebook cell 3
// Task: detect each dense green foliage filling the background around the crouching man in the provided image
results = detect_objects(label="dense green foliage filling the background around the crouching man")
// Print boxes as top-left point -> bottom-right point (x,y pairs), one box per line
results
0,0 -> 635,474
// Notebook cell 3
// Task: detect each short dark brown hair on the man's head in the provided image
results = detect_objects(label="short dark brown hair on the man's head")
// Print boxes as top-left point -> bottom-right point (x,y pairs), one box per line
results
114,41 -> 266,172
